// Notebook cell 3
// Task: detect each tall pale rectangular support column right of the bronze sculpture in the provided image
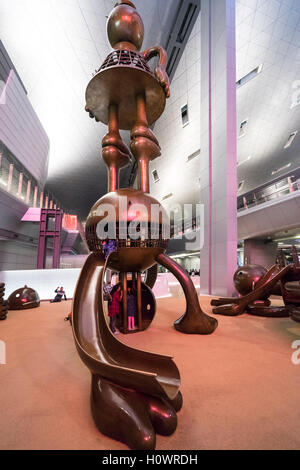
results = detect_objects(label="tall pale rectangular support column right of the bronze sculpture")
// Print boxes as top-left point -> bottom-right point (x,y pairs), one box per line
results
201,0 -> 237,296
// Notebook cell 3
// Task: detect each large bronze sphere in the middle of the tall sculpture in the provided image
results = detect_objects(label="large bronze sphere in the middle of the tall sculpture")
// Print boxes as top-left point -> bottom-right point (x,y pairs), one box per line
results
85,188 -> 169,272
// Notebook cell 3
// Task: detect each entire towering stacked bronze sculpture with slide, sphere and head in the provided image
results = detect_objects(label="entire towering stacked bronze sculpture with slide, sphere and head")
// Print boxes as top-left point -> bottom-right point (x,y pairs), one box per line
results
73,1 -> 217,449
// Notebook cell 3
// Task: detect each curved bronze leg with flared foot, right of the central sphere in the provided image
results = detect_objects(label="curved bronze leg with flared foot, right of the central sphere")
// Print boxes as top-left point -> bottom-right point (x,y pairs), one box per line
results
156,254 -> 218,335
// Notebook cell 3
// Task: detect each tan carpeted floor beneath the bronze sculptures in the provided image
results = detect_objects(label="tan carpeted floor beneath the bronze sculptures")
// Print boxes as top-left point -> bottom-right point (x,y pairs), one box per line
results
0,298 -> 300,450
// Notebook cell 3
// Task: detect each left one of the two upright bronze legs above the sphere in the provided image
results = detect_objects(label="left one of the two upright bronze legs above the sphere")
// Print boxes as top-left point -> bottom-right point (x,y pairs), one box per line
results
102,104 -> 130,192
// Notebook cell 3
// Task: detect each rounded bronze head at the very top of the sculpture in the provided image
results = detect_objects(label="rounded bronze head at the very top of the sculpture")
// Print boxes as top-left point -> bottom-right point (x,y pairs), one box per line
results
107,0 -> 144,51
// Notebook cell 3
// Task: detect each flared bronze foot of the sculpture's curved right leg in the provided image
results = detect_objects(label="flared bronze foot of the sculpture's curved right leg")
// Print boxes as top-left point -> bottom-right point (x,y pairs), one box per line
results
174,305 -> 218,335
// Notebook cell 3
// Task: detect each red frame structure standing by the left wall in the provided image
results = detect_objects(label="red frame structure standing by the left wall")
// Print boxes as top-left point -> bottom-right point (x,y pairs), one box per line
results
37,209 -> 63,269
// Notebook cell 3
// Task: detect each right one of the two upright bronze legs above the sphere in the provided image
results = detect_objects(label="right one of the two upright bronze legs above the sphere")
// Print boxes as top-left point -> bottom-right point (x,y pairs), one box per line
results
130,95 -> 160,193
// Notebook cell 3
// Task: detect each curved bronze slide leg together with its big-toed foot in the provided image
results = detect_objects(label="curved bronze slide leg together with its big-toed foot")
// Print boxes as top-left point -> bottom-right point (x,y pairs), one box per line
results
72,253 -> 180,449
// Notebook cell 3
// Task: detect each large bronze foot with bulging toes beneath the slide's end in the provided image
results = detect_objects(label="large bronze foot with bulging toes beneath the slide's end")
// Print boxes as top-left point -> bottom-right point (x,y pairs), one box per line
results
91,375 -> 182,450
